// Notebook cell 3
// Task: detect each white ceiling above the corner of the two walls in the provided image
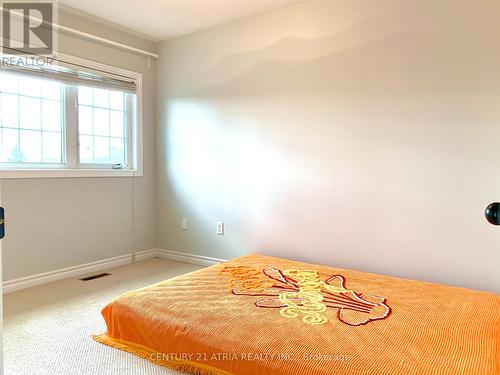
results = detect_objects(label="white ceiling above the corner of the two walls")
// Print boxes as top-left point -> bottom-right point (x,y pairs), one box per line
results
59,0 -> 301,41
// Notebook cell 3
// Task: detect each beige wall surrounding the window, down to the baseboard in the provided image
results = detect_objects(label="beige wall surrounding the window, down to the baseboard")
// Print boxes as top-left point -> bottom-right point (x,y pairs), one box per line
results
2,8 -> 156,280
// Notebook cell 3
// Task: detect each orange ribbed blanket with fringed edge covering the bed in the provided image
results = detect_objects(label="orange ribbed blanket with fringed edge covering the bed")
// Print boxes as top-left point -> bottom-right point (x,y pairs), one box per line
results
95,254 -> 500,375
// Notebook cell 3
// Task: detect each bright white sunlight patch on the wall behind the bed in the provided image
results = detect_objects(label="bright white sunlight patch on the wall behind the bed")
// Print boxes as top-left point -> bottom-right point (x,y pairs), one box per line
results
167,100 -> 295,225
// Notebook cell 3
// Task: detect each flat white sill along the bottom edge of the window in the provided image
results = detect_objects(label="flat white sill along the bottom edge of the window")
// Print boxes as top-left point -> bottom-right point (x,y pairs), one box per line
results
0,169 -> 143,179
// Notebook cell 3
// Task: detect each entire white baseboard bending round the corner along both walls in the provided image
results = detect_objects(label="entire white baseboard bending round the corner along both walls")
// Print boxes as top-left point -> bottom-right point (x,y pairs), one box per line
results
2,249 -> 226,294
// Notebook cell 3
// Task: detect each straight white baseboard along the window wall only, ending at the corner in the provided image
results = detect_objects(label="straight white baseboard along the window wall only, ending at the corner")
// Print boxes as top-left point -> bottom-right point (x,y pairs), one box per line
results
2,249 -> 157,294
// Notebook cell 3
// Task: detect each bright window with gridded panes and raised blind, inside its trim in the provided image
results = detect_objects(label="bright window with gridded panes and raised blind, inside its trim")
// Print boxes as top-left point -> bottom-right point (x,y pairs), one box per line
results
0,53 -> 141,177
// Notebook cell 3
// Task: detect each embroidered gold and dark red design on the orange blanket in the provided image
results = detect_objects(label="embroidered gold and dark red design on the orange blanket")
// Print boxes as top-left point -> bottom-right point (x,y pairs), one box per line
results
221,266 -> 391,326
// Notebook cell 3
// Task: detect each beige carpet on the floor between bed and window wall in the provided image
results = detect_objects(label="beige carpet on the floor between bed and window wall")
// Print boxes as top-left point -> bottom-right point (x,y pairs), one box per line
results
4,258 -> 201,375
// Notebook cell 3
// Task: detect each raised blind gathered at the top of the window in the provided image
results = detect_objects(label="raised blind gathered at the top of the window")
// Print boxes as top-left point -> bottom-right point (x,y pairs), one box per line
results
1,48 -> 136,93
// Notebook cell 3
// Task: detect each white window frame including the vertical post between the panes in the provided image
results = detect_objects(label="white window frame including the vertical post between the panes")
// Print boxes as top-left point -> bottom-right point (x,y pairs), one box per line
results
0,53 -> 143,179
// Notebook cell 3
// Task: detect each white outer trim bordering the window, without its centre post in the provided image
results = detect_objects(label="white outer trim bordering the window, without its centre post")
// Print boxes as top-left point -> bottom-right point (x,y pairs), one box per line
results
0,53 -> 143,179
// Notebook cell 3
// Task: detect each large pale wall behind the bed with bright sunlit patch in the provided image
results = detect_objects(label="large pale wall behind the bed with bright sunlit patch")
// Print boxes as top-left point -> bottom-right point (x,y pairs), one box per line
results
157,0 -> 500,292
